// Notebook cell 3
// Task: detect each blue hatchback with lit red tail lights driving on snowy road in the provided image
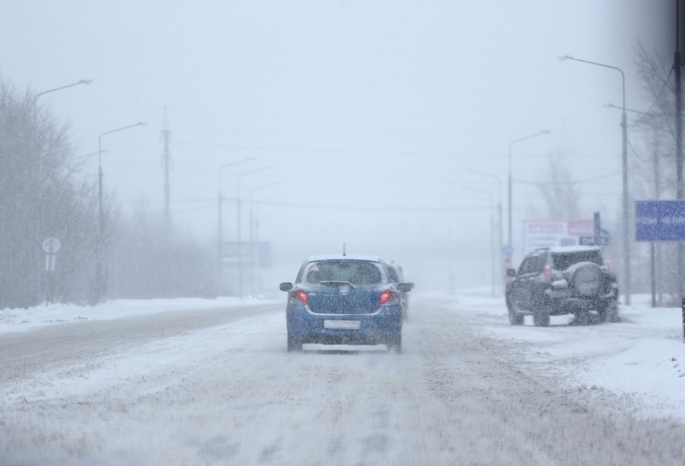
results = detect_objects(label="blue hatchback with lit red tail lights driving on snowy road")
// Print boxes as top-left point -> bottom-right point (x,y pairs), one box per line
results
280,255 -> 412,353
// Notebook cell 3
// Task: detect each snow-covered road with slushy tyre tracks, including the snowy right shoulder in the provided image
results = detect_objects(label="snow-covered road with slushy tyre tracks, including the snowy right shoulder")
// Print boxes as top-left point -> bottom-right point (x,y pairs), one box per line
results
0,295 -> 685,465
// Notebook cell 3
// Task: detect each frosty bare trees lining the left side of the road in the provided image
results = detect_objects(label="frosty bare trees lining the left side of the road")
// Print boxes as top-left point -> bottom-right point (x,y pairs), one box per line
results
0,81 -> 216,309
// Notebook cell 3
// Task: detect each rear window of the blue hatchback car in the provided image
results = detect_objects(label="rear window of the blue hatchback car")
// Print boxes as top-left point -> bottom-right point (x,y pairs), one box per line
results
304,260 -> 383,285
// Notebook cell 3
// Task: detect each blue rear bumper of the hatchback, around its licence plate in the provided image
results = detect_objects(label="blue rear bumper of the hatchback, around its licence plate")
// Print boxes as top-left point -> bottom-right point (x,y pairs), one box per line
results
286,304 -> 402,344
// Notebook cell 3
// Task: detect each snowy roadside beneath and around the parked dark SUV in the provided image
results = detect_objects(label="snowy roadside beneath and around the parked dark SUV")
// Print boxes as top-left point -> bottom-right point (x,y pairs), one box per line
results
438,292 -> 685,422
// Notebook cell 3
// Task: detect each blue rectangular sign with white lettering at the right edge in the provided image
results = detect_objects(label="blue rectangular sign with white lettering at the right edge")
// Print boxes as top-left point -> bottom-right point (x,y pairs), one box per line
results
635,201 -> 685,241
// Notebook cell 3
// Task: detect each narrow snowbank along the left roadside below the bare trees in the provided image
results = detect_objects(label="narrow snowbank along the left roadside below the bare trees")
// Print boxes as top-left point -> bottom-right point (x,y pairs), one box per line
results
0,297 -> 283,334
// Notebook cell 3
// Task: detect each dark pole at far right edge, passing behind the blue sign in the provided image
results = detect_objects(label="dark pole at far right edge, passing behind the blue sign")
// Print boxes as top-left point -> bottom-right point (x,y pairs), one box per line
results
673,0 -> 685,296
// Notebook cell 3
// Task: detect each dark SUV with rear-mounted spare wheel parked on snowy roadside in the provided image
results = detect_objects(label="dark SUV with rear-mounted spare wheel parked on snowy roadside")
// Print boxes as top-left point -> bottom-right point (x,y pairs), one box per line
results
505,246 -> 619,326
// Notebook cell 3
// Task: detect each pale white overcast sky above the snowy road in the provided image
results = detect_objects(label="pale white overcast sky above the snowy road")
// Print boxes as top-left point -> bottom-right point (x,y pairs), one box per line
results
0,0 -> 675,284
